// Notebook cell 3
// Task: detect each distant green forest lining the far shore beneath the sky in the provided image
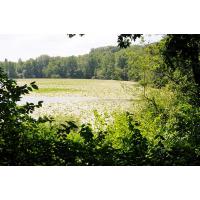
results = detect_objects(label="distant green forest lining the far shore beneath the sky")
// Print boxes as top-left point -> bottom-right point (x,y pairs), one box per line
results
0,45 -> 151,81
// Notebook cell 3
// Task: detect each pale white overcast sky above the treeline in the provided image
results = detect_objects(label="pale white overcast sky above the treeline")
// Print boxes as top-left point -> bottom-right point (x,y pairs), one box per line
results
0,34 -> 161,61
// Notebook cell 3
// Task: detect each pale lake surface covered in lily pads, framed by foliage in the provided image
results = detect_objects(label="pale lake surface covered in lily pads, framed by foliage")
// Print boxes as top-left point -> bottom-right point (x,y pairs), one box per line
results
17,79 -> 141,122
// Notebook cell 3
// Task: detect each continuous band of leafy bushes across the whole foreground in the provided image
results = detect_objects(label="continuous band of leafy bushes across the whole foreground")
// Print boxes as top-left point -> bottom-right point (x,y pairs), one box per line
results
0,67 -> 200,166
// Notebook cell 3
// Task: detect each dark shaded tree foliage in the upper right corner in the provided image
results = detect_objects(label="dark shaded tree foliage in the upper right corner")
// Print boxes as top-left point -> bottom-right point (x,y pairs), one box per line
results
162,34 -> 200,88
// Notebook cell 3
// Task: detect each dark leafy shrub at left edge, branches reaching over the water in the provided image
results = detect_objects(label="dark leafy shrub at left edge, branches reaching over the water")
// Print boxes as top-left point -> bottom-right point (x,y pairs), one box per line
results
0,69 -> 42,165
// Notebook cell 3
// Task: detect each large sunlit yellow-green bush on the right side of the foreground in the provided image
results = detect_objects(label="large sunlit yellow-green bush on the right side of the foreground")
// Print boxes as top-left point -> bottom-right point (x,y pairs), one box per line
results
137,87 -> 200,165
